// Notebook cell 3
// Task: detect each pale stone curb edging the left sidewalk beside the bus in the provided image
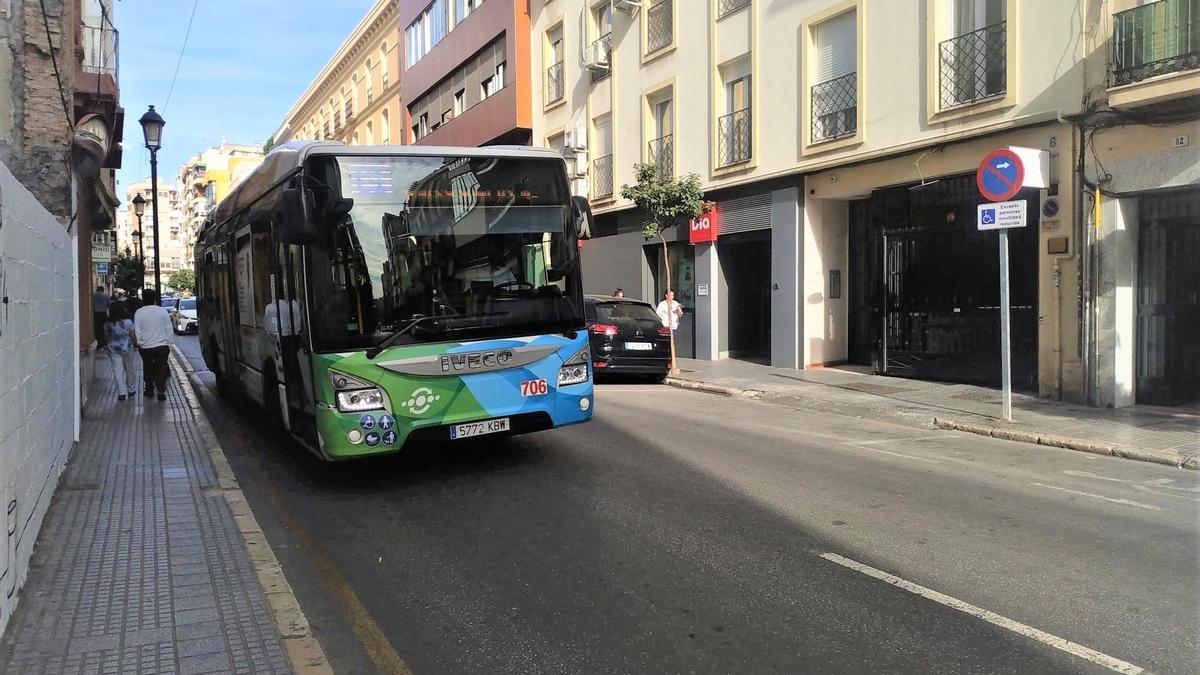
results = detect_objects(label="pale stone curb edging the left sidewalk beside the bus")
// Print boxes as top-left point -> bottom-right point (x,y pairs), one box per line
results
170,344 -> 334,675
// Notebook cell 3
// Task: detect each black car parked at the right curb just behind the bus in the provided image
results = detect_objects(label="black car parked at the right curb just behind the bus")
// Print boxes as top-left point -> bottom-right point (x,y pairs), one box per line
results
583,295 -> 671,382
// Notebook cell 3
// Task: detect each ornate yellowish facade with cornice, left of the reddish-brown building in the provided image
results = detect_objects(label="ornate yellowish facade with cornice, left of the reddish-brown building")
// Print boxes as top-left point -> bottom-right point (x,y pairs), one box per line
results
271,0 -> 404,145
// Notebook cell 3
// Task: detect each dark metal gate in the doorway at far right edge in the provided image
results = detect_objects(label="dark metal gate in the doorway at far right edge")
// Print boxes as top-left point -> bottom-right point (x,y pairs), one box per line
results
1136,191 -> 1200,406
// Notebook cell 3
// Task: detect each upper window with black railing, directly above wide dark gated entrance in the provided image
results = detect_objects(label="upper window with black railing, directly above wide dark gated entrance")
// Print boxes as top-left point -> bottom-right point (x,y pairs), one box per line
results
937,0 -> 1008,109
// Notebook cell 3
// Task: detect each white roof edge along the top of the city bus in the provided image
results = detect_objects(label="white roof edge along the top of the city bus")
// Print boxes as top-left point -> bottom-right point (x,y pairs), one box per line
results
207,141 -> 565,237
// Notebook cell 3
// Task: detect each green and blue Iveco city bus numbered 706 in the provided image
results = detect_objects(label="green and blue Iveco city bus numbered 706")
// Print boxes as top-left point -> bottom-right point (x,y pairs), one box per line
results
196,142 -> 593,460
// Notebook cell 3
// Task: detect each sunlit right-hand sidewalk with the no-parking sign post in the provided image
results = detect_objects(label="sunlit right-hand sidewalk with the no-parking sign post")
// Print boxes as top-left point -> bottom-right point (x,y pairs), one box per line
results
668,359 -> 1200,470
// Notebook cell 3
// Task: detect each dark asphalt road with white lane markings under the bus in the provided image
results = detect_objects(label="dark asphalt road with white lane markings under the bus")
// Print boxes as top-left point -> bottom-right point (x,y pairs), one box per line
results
180,338 -> 1200,674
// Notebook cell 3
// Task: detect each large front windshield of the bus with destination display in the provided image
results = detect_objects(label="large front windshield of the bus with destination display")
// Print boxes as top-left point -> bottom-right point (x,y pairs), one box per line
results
307,156 -> 584,351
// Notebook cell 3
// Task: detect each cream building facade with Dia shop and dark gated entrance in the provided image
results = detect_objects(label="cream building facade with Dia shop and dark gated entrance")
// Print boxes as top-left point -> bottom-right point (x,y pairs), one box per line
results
532,0 -> 1171,402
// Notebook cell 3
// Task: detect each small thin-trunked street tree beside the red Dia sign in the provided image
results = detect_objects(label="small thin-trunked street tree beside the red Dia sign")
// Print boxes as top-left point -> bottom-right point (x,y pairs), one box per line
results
620,165 -> 704,375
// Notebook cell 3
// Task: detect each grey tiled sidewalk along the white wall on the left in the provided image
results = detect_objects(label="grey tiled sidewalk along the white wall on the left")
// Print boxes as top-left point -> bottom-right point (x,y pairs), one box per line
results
0,348 -> 328,675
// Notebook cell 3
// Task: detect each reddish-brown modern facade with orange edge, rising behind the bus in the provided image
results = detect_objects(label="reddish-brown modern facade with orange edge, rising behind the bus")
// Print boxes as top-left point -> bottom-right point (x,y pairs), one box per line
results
400,0 -> 532,147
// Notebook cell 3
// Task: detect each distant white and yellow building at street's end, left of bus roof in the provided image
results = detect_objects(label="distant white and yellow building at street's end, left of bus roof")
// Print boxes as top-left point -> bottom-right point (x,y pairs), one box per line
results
179,141 -> 264,269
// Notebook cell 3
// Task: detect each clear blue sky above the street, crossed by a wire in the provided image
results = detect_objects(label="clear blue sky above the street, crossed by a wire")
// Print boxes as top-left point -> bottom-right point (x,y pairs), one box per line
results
113,0 -> 374,194
